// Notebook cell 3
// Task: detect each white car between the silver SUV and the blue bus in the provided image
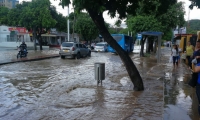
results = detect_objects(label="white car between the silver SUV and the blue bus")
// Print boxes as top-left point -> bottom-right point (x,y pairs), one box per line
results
94,42 -> 108,52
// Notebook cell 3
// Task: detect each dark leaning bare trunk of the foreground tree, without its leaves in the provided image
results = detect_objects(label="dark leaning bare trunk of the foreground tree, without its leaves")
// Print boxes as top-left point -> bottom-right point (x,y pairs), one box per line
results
88,10 -> 144,91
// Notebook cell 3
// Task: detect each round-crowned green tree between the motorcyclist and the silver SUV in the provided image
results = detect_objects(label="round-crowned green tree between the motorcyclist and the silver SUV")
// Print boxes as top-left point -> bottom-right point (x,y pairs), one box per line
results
20,0 -> 56,50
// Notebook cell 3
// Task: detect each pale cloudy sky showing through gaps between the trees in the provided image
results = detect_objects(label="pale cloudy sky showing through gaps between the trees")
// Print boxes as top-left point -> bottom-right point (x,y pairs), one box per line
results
19,0 -> 200,25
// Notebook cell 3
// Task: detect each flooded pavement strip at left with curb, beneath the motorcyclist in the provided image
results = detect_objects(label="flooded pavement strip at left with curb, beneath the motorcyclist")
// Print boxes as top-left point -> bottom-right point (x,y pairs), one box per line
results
0,48 -> 59,65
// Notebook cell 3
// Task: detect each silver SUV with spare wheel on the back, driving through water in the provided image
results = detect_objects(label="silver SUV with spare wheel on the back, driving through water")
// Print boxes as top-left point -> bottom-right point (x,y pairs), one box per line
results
59,42 -> 91,59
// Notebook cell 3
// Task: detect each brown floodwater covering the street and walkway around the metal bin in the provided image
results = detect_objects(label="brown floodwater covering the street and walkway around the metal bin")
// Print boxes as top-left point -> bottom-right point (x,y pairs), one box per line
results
0,48 -> 198,120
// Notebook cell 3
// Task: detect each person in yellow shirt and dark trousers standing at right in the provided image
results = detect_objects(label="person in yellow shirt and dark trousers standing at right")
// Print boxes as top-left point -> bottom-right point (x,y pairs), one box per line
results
186,42 -> 194,69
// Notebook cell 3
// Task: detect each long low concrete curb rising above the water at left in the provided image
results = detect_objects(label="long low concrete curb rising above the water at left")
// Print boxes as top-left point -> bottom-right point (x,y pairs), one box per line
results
0,55 -> 60,65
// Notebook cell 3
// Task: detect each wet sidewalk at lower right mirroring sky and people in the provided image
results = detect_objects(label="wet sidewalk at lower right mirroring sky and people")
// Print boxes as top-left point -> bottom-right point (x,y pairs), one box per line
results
164,67 -> 198,120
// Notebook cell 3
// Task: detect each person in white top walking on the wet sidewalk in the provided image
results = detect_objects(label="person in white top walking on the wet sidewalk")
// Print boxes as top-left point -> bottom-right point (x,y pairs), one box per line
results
171,44 -> 179,68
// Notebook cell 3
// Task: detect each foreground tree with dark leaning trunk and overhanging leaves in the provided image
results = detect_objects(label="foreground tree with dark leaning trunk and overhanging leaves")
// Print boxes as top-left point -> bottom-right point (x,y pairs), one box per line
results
61,0 -> 176,90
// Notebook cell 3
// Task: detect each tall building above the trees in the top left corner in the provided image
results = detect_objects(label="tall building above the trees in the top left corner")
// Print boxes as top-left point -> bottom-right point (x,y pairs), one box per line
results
0,0 -> 19,9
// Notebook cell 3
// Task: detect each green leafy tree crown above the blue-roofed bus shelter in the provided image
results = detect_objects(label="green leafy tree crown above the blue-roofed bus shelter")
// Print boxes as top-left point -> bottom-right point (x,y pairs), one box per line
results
126,2 -> 185,37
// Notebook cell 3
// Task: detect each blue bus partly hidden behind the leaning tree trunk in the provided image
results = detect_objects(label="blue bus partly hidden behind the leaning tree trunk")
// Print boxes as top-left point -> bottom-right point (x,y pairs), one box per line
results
108,34 -> 134,53
